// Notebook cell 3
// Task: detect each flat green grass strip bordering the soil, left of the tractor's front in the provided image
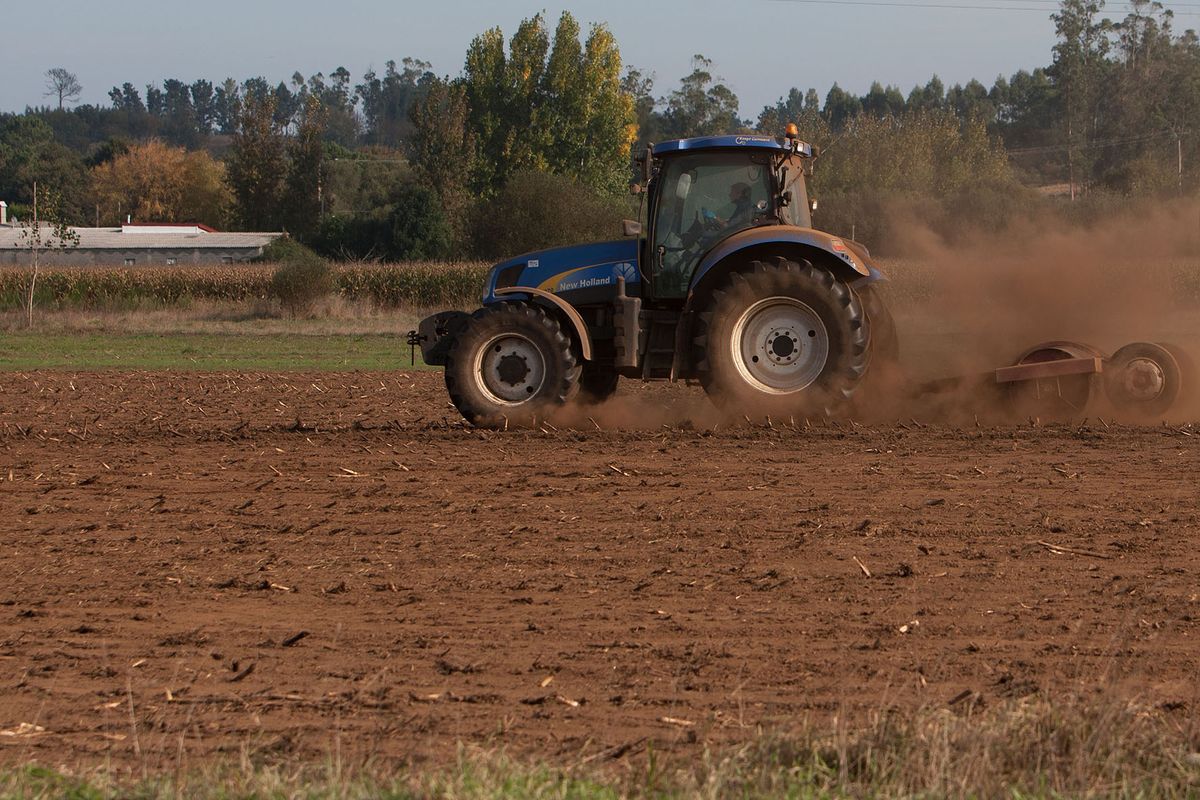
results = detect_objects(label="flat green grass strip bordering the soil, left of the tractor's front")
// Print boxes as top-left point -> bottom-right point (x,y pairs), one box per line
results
0,331 -> 426,372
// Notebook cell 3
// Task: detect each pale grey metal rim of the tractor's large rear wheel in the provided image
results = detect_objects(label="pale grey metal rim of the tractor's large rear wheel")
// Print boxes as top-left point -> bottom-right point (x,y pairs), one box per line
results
731,297 -> 829,395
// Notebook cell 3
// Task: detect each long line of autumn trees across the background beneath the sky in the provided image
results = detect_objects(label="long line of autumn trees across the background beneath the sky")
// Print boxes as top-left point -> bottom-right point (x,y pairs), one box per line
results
0,0 -> 1200,259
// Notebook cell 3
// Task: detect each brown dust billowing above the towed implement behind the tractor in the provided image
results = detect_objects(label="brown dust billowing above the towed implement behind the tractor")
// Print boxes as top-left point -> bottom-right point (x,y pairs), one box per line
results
876,203 -> 1200,419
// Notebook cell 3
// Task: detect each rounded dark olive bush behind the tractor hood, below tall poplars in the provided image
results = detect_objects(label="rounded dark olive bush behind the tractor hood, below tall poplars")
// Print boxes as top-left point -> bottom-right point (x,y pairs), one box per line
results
472,172 -> 634,258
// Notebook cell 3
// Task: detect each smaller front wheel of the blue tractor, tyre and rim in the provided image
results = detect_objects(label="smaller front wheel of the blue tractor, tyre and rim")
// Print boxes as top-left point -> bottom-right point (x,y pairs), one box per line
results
445,302 -> 580,427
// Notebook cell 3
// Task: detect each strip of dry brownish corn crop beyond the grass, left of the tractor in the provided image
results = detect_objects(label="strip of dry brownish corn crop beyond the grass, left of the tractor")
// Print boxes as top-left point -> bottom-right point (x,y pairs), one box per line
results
0,261 -> 488,309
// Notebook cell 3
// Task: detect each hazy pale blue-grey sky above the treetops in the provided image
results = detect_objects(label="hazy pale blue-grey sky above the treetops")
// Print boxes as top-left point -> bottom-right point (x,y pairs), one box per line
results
0,0 -> 1080,116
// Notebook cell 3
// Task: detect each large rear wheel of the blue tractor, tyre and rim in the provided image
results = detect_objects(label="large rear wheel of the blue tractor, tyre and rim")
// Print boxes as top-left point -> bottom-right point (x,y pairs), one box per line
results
696,258 -> 870,419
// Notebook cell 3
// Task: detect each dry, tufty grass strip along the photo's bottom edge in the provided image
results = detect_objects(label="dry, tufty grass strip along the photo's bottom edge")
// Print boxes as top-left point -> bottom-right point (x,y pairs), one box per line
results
0,696 -> 1200,800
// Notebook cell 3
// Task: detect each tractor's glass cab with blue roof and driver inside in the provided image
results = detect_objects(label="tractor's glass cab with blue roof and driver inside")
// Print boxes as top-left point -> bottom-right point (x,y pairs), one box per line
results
638,128 -> 812,300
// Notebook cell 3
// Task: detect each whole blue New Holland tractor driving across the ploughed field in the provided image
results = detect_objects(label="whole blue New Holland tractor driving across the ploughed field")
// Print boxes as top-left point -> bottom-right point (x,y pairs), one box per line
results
409,126 -> 895,427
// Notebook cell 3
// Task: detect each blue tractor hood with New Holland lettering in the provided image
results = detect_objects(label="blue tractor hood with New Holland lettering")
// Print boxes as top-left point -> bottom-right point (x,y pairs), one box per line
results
484,239 -> 641,303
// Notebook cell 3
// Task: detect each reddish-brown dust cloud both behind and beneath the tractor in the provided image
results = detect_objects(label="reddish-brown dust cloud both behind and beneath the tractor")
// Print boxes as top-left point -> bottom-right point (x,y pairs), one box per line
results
554,203 -> 1200,429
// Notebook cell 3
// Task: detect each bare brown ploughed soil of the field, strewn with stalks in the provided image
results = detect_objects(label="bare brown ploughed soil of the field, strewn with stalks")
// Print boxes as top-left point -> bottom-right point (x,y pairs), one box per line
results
0,373 -> 1200,769
